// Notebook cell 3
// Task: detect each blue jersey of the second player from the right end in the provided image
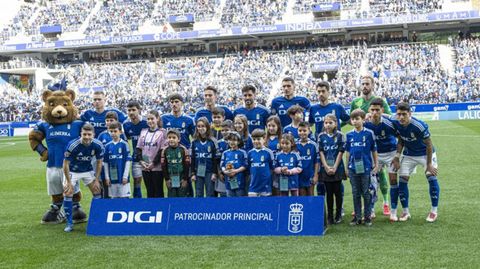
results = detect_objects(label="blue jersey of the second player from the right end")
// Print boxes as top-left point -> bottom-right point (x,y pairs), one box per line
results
364,116 -> 397,153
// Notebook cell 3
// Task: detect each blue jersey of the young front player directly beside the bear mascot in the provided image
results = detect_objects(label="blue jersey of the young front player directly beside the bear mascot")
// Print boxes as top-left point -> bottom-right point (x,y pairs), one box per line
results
65,138 -> 105,173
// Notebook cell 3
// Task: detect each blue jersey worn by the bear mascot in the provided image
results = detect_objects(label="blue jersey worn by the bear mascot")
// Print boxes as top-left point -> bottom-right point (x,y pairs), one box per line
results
34,121 -> 83,168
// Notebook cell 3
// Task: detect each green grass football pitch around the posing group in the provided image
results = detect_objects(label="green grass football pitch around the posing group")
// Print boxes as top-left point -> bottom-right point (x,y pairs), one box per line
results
0,120 -> 480,268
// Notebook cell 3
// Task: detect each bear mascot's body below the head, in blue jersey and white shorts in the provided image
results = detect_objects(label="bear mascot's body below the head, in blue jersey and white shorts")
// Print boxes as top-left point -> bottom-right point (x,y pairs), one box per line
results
32,112 -> 87,224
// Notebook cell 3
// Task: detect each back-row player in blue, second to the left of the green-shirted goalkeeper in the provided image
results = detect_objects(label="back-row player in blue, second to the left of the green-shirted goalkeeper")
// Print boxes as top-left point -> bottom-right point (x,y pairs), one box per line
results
270,77 -> 310,128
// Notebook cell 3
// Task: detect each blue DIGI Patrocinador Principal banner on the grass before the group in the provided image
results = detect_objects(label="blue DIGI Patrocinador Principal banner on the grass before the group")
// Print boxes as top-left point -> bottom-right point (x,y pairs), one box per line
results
87,196 -> 324,236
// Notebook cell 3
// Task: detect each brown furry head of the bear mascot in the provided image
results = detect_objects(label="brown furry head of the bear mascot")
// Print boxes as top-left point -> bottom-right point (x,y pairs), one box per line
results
42,90 -> 78,124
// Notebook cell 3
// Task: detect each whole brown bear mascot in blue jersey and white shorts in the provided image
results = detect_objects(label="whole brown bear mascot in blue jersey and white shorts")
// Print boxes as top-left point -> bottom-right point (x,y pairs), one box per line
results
28,90 -> 87,224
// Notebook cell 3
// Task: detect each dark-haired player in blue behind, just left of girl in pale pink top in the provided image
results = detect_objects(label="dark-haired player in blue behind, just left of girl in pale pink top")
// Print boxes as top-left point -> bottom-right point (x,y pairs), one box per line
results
123,101 -> 149,198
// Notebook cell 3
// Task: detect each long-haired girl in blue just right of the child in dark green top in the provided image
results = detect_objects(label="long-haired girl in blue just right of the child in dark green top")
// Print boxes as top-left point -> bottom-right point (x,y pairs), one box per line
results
191,117 -> 218,197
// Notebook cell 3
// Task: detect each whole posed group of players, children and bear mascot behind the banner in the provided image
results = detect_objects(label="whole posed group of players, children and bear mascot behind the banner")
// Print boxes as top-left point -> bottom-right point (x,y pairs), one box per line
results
30,76 -> 440,232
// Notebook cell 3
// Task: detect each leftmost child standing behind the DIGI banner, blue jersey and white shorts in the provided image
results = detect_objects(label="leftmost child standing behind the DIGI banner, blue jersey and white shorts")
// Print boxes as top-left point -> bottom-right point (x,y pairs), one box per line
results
103,122 -> 132,198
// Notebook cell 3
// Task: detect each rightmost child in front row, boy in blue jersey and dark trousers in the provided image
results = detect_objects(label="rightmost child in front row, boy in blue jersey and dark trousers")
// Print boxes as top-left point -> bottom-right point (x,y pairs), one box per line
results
345,109 -> 378,226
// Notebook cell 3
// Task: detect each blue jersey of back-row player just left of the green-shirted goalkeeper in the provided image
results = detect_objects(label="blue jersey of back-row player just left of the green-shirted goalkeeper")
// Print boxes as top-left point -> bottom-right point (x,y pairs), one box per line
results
308,103 -> 350,138
